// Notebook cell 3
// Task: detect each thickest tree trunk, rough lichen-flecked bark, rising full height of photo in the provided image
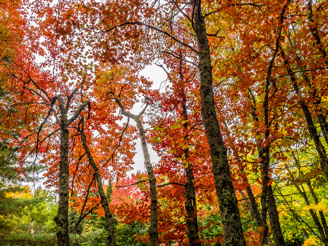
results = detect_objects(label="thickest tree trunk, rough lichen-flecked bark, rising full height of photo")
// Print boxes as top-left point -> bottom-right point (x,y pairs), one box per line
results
192,0 -> 246,246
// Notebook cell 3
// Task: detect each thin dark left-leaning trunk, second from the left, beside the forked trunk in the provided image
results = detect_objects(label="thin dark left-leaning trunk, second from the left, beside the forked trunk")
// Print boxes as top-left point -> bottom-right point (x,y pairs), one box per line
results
81,122 -> 116,246
